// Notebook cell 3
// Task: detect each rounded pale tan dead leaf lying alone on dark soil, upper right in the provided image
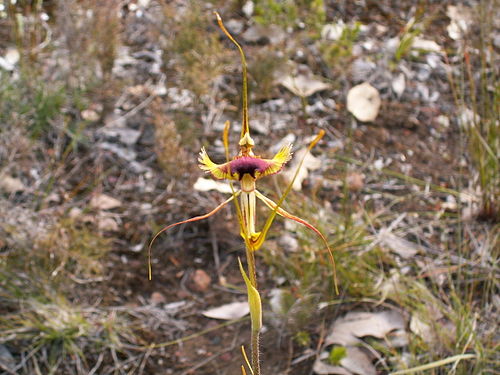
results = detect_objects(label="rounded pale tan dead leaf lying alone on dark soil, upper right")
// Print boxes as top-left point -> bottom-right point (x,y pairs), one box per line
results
347,82 -> 381,122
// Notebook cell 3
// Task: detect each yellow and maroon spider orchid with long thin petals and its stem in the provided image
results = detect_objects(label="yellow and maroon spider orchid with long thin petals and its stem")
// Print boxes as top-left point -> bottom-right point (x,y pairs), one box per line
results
148,13 -> 338,375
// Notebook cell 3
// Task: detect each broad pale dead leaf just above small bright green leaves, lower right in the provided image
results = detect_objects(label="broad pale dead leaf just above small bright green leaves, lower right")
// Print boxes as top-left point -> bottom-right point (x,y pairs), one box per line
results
325,310 -> 405,346
